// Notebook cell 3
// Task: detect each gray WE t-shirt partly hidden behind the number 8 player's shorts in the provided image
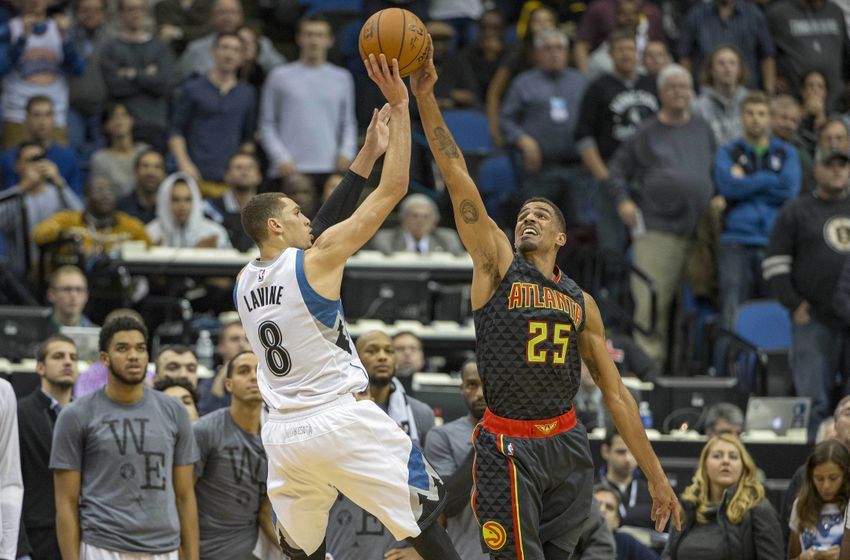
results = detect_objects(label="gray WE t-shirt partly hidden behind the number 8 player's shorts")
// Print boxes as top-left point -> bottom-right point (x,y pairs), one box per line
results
193,408 -> 268,560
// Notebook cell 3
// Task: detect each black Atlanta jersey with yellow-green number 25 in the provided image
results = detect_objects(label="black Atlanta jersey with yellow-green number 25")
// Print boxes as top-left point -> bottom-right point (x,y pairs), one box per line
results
474,255 -> 584,420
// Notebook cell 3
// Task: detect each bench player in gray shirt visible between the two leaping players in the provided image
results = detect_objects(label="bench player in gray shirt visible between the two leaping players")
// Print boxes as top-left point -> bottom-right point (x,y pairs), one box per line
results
425,359 -> 490,560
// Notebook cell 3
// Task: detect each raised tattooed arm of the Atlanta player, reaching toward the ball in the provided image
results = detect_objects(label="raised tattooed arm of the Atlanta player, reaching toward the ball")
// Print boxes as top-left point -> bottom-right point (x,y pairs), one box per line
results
410,49 -> 513,307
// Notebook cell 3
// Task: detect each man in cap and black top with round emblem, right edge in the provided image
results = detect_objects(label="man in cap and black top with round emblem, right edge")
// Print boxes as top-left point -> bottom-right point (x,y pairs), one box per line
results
762,148 -> 850,440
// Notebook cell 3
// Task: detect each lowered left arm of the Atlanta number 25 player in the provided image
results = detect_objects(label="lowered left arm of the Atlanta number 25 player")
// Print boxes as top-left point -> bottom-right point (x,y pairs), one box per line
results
579,293 -> 682,531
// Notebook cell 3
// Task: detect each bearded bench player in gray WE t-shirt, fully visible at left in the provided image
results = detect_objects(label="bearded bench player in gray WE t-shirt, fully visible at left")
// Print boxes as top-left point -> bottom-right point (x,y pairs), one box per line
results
50,317 -> 198,560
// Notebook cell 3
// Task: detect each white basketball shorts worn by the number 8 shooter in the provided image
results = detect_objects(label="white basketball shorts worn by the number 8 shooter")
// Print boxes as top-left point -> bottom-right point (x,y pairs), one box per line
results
263,395 -> 445,554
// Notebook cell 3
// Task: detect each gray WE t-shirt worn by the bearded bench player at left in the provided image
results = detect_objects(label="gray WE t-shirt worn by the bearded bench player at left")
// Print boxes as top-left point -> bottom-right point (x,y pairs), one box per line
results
50,387 -> 198,554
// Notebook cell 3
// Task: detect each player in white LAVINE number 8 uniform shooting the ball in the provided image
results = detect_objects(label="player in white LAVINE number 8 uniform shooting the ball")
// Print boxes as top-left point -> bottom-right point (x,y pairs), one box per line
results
234,55 -> 460,560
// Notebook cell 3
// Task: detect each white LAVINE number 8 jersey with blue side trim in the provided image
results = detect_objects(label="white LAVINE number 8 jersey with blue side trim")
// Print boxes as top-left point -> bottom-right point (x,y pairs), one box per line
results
233,248 -> 369,411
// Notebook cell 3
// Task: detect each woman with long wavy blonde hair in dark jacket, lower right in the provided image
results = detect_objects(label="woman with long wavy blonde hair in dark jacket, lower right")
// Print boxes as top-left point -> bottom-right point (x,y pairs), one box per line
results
662,434 -> 785,560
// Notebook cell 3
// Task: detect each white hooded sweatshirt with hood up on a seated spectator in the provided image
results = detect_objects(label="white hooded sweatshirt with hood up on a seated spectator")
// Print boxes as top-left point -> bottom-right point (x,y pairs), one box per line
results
145,173 -> 231,249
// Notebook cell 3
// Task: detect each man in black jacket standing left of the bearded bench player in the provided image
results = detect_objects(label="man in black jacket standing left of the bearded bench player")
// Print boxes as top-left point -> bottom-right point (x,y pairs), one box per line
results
18,334 -> 78,560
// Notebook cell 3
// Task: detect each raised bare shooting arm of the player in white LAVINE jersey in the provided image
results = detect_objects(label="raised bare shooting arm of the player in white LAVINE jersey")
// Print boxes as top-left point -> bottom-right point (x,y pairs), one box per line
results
305,54 -> 411,274
